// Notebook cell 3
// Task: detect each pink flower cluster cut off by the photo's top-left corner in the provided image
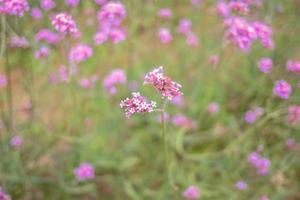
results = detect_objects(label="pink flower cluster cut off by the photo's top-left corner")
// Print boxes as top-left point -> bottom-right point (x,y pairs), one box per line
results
0,0 -> 29,17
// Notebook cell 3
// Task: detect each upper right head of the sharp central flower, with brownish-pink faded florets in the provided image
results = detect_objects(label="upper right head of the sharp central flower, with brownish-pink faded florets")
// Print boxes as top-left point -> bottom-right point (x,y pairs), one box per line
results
144,66 -> 182,100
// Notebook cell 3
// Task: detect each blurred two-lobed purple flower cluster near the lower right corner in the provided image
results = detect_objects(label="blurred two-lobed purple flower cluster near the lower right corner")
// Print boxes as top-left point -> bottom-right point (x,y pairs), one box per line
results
248,152 -> 271,176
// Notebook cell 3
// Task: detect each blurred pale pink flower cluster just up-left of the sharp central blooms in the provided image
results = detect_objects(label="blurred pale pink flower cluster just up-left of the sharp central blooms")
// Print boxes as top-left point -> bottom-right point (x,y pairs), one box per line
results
103,69 -> 127,95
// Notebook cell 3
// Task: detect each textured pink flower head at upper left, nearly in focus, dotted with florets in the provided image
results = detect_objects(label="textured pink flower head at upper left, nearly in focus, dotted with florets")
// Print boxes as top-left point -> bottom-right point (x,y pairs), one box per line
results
52,13 -> 78,33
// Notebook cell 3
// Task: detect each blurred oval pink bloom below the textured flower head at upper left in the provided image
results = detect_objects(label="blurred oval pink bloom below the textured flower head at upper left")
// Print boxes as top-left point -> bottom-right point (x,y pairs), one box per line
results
69,44 -> 93,64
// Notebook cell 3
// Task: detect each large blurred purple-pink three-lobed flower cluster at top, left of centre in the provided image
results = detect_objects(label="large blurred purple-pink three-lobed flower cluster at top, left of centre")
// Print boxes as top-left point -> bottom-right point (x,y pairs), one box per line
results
94,2 -> 126,45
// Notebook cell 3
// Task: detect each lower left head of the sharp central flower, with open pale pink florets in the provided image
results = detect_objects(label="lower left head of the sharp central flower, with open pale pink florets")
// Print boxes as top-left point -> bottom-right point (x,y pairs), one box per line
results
120,92 -> 156,118
